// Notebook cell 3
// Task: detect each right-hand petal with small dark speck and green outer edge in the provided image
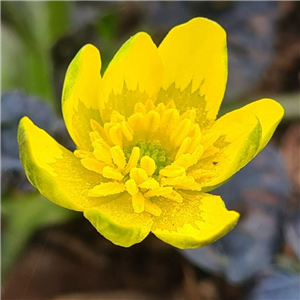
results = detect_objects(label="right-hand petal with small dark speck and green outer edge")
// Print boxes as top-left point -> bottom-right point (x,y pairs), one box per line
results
193,115 -> 262,192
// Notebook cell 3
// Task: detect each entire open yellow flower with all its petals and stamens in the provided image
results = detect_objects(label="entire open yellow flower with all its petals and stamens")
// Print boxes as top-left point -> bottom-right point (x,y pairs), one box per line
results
18,18 -> 283,248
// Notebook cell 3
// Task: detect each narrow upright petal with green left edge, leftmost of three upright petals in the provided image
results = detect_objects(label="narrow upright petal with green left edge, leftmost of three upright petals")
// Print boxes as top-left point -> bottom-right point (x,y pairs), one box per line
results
62,44 -> 101,150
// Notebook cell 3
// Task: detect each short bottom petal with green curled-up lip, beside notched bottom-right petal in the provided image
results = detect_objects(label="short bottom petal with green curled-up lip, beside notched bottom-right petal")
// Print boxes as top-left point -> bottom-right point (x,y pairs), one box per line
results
84,193 -> 153,247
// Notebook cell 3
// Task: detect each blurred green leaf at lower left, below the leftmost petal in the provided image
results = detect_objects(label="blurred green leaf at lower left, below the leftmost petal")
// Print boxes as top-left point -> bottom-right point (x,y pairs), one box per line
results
0,192 -> 78,283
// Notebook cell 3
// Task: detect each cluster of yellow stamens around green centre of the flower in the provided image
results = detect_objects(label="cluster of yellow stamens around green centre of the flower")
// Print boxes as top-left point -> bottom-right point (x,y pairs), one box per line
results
74,100 -> 219,216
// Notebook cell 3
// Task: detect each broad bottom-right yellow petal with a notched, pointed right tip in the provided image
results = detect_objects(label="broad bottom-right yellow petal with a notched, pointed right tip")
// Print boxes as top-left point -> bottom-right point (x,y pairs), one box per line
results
151,192 -> 239,249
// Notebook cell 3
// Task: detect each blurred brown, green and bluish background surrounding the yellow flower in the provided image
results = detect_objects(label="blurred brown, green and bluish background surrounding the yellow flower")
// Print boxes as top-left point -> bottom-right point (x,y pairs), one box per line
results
0,0 -> 300,300
